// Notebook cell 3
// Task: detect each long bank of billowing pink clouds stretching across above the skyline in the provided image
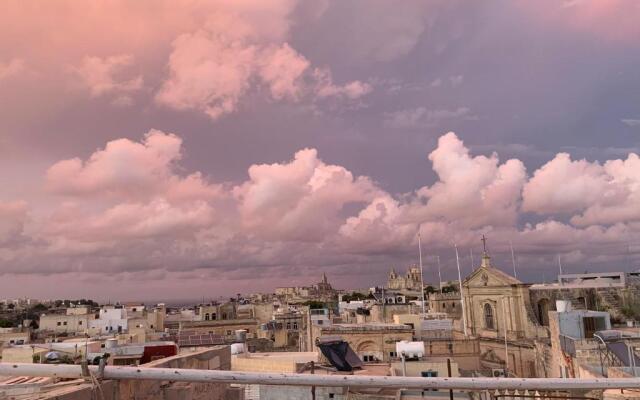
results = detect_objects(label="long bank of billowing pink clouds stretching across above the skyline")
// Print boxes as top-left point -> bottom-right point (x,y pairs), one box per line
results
5,130 -> 640,294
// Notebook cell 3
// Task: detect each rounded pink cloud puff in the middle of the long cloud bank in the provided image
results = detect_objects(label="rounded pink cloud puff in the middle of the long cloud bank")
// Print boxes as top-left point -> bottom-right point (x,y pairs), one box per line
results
234,149 -> 379,241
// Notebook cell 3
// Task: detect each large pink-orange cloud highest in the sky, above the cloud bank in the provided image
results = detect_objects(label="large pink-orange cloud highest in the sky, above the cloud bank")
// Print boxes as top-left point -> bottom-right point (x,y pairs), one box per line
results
156,1 -> 371,119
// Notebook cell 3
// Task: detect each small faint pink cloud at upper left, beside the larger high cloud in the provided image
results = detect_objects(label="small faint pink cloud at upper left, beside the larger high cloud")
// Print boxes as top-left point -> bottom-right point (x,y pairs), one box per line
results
76,54 -> 143,105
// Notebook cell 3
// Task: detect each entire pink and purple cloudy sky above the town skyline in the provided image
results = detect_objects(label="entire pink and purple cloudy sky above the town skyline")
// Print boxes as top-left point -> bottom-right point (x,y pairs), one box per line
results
0,0 -> 640,300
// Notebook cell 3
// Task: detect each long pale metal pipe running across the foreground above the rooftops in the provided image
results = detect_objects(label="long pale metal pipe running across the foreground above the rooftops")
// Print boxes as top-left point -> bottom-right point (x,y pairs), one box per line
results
0,363 -> 640,391
